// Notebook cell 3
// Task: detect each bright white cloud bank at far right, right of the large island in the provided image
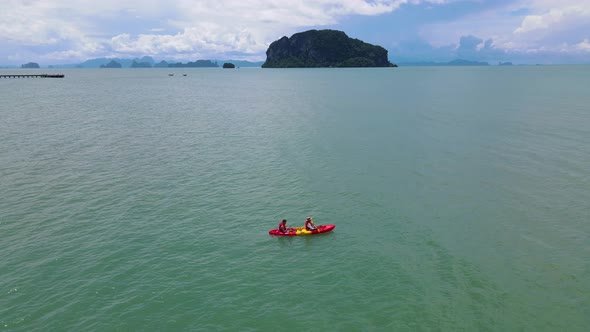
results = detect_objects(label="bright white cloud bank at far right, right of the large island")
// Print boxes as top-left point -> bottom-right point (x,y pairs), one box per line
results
414,0 -> 590,64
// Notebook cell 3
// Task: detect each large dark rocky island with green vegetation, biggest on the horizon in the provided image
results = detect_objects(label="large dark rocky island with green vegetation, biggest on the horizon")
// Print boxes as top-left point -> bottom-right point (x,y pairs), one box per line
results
262,30 -> 397,68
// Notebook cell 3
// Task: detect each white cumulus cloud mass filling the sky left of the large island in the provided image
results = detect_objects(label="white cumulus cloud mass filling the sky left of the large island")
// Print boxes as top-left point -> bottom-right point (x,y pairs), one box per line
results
0,0 -> 452,60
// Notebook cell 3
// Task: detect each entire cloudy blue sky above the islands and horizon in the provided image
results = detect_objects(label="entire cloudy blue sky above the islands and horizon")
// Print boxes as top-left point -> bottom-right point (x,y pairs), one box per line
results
0,0 -> 590,65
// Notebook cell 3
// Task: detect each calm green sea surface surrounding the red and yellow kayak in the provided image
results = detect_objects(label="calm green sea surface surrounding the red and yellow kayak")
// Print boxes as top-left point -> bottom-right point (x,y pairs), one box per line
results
0,66 -> 590,331
